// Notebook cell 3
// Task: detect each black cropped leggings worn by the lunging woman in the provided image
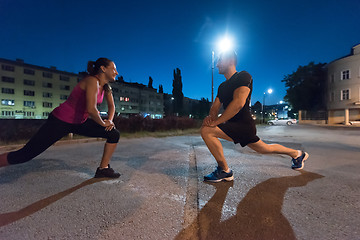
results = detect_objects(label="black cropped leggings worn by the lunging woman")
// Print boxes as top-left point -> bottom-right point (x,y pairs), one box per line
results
8,114 -> 120,164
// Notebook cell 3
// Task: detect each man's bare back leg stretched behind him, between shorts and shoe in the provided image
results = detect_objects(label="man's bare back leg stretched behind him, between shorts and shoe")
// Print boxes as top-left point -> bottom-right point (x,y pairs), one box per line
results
248,140 -> 299,158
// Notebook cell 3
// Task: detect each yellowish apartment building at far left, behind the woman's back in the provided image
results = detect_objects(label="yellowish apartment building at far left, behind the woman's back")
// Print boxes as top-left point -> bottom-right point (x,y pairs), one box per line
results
0,58 -> 79,119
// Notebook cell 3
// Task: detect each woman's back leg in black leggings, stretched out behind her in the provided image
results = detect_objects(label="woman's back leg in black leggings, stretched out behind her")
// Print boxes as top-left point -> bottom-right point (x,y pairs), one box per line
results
7,115 -> 69,164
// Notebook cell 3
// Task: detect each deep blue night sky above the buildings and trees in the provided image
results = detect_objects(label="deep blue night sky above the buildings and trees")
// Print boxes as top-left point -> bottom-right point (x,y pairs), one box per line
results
0,0 -> 360,104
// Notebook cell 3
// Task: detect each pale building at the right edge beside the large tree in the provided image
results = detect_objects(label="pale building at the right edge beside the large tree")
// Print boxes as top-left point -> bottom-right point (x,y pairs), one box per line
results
327,44 -> 360,125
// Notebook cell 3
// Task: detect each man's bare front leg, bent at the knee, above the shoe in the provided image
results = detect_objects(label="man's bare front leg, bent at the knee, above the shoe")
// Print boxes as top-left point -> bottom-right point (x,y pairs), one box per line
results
201,126 -> 233,172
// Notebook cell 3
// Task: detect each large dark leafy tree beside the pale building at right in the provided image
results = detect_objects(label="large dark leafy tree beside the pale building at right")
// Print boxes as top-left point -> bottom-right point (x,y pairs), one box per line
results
282,62 -> 326,111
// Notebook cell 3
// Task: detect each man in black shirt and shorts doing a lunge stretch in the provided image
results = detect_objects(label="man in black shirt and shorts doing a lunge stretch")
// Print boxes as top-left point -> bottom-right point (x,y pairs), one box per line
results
201,51 -> 309,182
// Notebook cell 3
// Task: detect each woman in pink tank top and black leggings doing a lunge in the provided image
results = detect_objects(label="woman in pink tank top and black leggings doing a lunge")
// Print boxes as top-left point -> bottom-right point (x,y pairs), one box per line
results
0,58 -> 120,178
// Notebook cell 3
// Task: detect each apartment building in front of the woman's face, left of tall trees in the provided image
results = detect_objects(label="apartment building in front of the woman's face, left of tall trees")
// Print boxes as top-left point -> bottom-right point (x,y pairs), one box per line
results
99,81 -> 164,119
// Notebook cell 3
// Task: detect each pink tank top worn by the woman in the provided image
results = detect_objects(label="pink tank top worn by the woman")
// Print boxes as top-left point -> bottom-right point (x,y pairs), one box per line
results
52,84 -> 104,124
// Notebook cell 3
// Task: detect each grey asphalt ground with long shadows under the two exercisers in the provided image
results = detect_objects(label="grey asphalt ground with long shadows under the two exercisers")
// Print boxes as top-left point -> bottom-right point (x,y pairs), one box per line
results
0,126 -> 360,240
